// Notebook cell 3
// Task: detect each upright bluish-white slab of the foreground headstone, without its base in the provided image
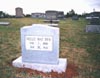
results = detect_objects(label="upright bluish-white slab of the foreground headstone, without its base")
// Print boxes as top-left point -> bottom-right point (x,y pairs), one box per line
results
21,24 -> 59,64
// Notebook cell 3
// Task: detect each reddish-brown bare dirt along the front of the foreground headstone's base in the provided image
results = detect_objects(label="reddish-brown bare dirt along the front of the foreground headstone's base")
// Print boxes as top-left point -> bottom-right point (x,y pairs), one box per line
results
17,63 -> 78,78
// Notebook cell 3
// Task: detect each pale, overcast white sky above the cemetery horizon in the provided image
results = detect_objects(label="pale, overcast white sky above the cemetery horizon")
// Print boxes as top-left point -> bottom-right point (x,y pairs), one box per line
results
0,0 -> 100,15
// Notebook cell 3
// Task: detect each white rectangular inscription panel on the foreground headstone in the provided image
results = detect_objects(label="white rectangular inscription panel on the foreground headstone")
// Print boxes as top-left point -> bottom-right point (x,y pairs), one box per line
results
25,36 -> 53,51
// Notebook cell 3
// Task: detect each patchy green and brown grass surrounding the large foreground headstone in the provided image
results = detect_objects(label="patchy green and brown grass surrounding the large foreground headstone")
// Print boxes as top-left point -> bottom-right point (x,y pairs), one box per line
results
0,18 -> 100,78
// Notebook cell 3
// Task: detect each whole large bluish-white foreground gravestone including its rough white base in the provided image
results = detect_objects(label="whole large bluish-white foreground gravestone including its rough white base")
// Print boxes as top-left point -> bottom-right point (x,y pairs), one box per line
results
13,24 -> 67,72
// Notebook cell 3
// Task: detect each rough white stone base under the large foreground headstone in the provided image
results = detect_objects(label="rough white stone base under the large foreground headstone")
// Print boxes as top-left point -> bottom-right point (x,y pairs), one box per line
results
12,56 -> 67,73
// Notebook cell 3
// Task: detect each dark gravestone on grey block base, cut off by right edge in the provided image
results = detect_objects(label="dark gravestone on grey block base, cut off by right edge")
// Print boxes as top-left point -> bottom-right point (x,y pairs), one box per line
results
86,17 -> 100,33
